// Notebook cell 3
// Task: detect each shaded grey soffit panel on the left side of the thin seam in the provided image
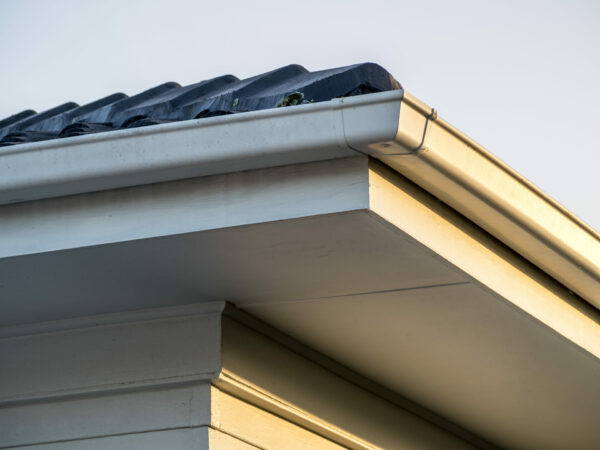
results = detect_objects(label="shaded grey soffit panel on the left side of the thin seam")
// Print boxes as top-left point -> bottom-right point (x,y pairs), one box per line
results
0,210 -> 466,325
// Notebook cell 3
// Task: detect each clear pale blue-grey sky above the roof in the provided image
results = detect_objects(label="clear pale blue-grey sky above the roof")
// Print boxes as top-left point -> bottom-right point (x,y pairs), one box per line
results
0,0 -> 600,230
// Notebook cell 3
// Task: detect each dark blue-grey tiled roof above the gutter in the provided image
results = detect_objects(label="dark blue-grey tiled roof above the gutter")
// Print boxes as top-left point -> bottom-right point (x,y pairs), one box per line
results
0,63 -> 401,146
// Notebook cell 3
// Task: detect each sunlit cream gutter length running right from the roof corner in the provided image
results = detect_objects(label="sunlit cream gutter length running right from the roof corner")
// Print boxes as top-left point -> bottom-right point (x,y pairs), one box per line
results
344,93 -> 600,308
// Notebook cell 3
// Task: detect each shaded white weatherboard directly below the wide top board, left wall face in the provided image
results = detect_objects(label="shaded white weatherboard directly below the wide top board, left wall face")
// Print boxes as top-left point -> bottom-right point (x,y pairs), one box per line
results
0,382 -> 211,448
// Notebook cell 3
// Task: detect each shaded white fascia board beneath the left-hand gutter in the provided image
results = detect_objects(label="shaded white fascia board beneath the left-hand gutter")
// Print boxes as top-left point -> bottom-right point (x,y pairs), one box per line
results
0,157 -> 369,258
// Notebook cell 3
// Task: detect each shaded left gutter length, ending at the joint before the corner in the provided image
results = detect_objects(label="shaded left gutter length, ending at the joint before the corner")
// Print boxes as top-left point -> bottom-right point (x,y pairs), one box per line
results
0,101 -> 364,205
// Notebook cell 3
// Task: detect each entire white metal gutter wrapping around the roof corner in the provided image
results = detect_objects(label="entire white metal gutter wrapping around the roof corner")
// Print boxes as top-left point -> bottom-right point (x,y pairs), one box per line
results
0,91 -> 600,308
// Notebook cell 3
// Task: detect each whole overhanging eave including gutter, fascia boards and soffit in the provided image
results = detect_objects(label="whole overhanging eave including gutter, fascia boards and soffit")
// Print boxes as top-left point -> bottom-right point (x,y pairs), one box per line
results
0,91 -> 600,448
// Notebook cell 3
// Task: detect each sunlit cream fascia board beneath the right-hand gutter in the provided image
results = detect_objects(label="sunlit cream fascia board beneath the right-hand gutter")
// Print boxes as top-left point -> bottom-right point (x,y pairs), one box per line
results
369,161 -> 600,358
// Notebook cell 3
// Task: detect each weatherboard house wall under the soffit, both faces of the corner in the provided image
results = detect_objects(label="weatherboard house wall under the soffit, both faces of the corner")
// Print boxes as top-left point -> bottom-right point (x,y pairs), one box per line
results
0,304 -> 482,450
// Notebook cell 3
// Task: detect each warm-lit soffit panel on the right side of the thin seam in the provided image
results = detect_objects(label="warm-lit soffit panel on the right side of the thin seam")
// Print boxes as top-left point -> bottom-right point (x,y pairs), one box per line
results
245,284 -> 600,449
